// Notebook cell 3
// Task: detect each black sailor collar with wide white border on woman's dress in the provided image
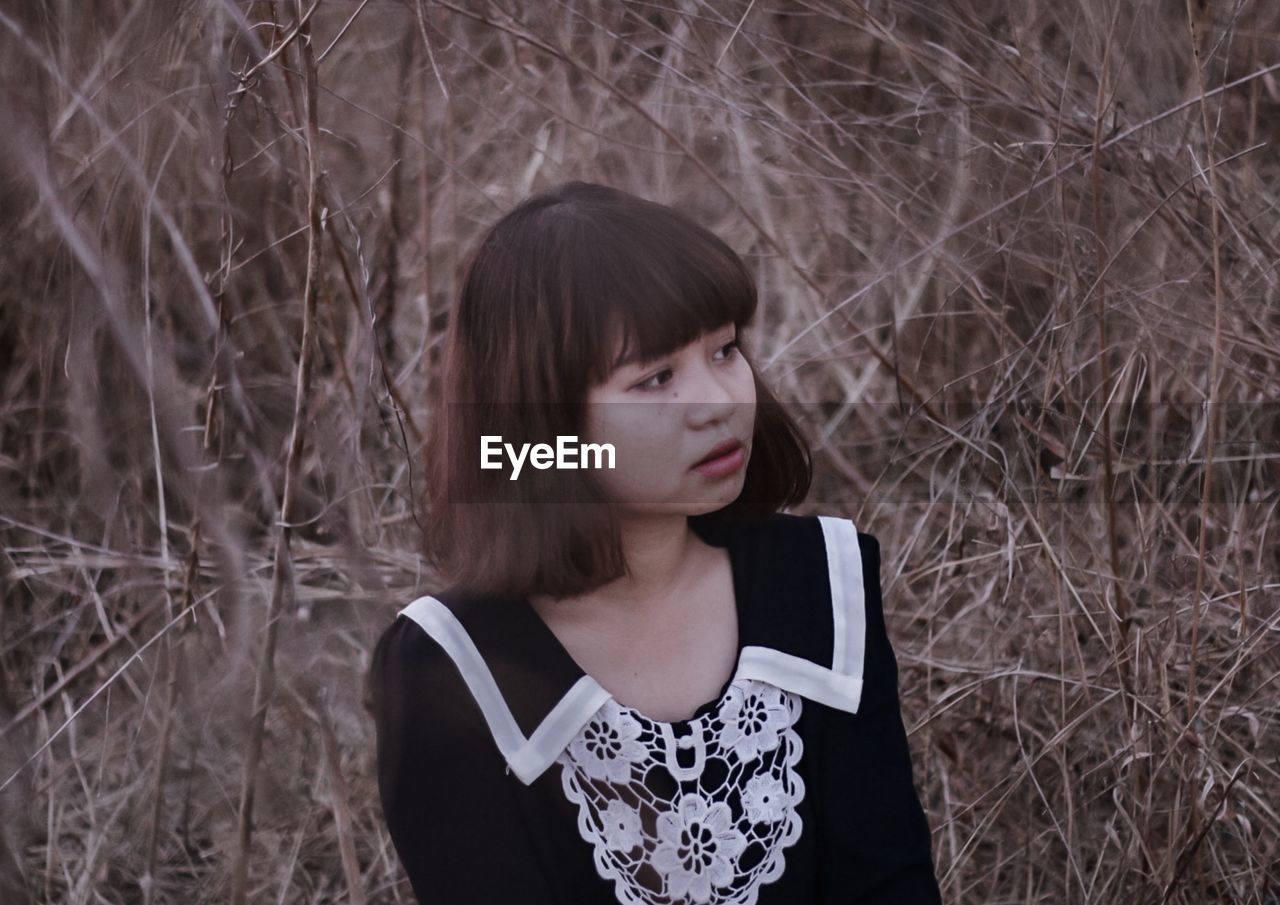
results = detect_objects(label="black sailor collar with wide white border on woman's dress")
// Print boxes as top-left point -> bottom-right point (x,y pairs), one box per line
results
399,513 -> 878,785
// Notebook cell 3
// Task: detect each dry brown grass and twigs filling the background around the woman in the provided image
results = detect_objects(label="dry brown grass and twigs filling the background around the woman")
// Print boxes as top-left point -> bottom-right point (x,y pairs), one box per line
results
0,0 -> 1280,905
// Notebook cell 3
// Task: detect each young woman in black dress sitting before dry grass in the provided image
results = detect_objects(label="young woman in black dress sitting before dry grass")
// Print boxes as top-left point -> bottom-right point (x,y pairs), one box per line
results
370,183 -> 940,905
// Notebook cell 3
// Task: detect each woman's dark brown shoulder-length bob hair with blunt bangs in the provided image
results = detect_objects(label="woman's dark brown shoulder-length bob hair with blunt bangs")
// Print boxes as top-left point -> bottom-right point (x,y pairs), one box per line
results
422,182 -> 812,598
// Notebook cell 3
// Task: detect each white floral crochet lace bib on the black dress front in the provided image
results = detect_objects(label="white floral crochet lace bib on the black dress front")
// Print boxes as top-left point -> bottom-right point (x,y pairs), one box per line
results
556,678 -> 804,905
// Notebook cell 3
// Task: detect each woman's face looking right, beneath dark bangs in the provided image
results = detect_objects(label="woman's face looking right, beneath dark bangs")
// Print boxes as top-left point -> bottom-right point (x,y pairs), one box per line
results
584,324 -> 755,515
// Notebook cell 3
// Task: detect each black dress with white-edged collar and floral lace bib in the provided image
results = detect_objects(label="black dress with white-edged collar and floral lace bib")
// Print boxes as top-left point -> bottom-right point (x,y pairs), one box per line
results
370,513 -> 941,905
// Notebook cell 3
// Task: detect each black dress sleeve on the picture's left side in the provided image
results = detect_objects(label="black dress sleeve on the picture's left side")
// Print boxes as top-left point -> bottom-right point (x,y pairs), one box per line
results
369,616 -> 550,905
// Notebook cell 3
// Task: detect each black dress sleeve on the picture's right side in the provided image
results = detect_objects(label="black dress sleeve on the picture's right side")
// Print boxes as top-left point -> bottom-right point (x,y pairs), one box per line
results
828,531 -> 941,905
